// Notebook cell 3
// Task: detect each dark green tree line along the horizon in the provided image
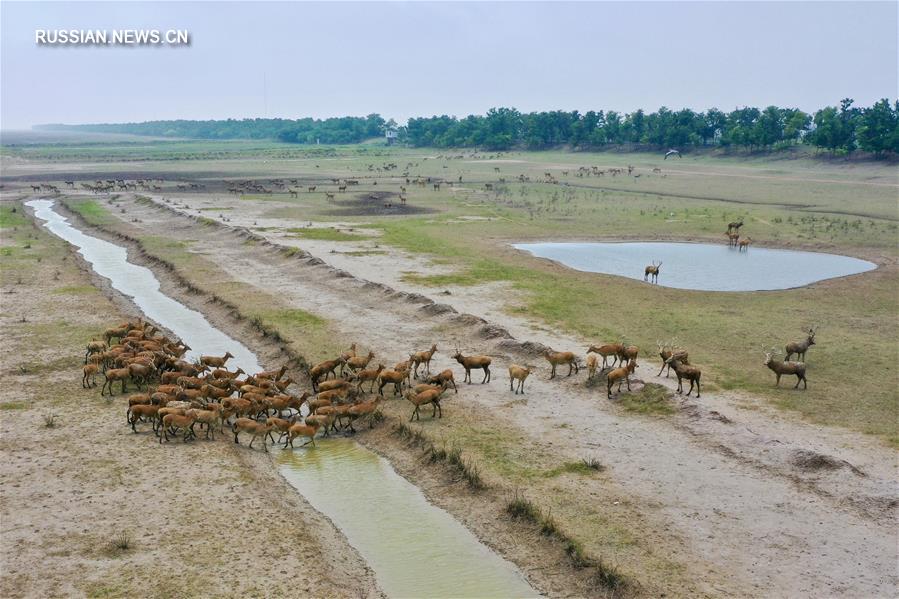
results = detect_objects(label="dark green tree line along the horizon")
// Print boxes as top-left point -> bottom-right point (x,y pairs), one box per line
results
42,98 -> 899,155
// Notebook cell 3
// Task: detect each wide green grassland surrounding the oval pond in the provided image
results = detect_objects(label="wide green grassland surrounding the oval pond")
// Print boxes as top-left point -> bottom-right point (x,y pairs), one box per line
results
6,142 -> 899,446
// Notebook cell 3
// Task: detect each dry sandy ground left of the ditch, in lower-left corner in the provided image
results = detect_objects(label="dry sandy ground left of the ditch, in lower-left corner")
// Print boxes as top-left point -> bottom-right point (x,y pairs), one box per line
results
0,204 -> 379,597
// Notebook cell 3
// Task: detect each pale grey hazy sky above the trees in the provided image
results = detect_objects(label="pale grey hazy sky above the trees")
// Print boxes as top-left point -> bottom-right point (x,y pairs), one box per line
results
0,0 -> 899,129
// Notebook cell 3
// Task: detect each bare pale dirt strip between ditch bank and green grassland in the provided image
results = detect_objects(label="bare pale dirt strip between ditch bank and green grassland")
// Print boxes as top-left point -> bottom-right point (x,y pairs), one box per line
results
72,195 -> 897,596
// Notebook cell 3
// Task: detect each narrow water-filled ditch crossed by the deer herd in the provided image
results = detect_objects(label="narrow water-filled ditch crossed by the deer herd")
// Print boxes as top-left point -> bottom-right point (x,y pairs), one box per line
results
27,200 -> 538,598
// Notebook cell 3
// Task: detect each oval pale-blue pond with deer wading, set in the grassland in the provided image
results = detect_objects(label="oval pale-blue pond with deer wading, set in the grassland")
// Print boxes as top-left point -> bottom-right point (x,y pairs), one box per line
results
514,242 -> 877,291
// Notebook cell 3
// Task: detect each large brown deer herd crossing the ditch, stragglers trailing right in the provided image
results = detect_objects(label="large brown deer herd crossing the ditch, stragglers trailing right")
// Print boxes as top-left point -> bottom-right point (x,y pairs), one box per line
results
81,320 -> 816,451
